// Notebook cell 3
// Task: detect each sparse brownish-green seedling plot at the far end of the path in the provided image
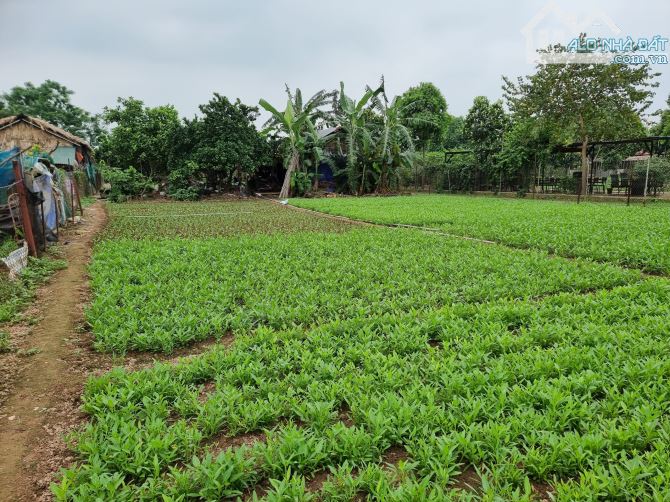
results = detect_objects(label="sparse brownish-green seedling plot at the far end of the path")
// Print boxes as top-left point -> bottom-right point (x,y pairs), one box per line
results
103,199 -> 351,239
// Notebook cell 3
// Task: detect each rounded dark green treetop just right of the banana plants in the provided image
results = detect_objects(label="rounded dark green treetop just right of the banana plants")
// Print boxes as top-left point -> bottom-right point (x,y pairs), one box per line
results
400,82 -> 450,152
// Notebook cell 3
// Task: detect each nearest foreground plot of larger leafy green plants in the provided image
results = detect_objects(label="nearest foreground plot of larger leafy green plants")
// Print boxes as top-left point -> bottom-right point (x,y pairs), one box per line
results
54,280 -> 670,500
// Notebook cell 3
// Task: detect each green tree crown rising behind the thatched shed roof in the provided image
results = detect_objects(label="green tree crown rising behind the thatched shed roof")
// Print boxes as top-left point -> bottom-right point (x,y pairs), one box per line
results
0,80 -> 95,139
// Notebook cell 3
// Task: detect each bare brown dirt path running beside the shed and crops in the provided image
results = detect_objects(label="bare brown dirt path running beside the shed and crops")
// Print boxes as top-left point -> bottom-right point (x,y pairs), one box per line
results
0,202 -> 106,501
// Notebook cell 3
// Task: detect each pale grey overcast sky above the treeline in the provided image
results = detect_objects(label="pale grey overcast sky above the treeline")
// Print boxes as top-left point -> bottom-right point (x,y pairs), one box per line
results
0,0 -> 670,121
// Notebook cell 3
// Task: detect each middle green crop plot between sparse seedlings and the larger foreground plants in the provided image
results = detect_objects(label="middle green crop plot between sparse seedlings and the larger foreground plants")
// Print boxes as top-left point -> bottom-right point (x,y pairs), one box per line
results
87,228 -> 640,353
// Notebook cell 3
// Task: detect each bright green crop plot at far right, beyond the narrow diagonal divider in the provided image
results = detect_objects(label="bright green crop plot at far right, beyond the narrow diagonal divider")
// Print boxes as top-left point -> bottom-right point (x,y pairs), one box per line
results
291,195 -> 670,274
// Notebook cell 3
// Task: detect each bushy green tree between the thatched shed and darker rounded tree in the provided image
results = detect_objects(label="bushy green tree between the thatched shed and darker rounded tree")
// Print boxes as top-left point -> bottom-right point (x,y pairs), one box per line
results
99,97 -> 179,178
